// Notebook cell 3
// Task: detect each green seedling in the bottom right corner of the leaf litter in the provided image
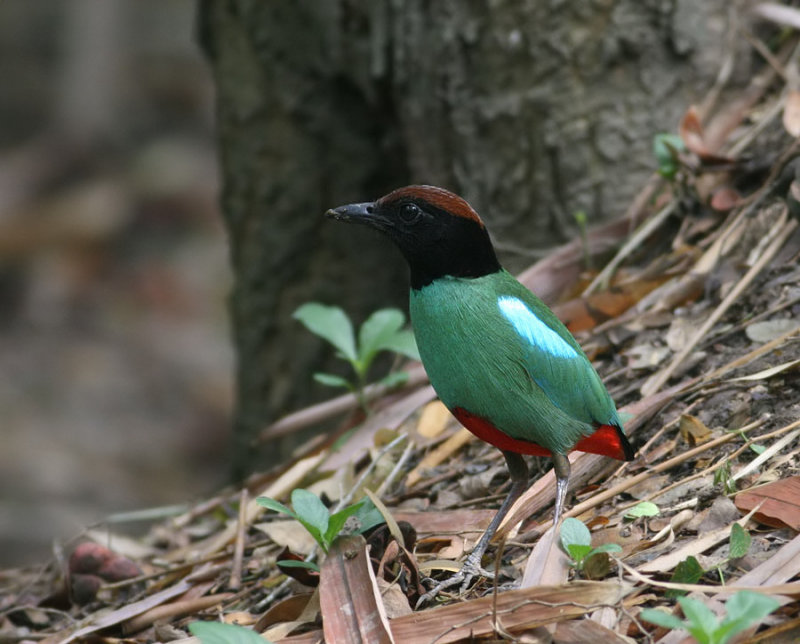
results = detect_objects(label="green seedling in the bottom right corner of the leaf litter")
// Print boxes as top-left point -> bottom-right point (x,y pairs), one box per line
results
639,590 -> 780,644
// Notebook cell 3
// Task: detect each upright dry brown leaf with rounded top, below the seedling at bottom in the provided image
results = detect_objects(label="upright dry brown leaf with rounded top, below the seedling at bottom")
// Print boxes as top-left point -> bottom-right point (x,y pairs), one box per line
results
319,535 -> 395,644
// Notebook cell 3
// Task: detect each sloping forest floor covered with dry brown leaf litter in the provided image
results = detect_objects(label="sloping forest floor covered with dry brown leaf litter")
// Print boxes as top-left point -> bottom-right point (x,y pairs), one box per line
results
0,22 -> 800,644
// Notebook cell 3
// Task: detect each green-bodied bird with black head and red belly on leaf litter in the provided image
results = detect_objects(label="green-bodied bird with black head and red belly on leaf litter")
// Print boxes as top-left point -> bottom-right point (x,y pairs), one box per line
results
325,185 -> 634,597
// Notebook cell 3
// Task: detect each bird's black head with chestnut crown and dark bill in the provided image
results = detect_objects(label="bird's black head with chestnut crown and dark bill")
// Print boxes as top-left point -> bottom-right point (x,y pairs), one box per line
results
325,186 -> 500,289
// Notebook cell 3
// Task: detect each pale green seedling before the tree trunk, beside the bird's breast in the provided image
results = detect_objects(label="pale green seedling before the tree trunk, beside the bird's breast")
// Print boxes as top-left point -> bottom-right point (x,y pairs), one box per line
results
292,302 -> 419,408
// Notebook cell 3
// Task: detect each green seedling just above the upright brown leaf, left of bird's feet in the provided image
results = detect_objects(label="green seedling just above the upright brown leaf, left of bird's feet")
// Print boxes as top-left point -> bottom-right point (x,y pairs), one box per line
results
256,489 -> 383,572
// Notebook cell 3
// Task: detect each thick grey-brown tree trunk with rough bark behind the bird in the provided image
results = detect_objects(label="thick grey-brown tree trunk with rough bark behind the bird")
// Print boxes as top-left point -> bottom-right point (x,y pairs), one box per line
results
200,0 -> 744,474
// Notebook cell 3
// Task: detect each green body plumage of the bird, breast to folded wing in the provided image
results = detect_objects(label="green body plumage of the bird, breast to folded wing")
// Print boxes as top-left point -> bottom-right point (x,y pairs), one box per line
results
410,271 -> 621,454
